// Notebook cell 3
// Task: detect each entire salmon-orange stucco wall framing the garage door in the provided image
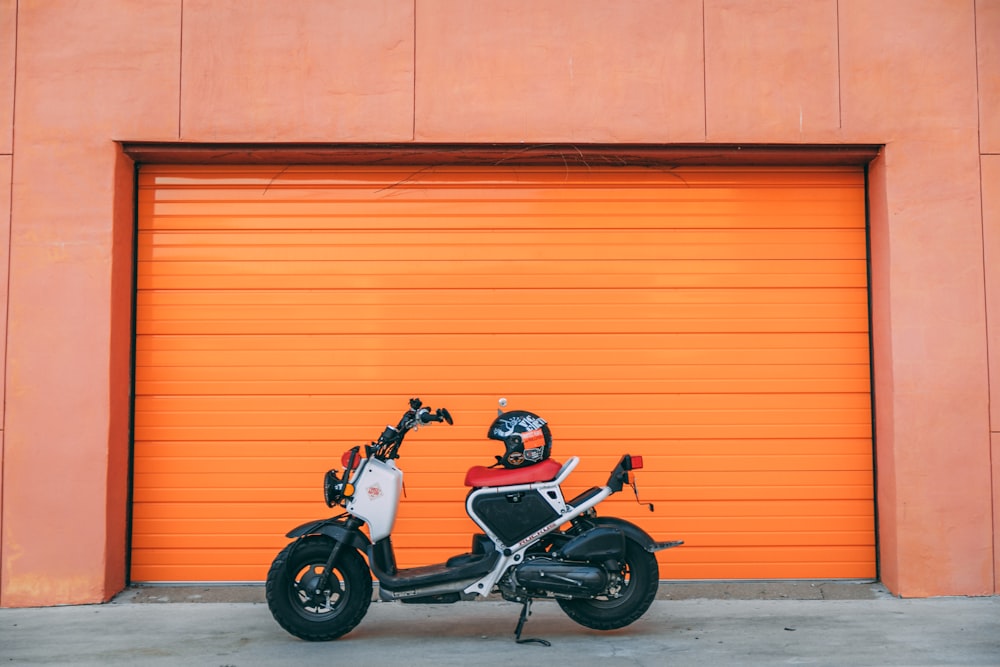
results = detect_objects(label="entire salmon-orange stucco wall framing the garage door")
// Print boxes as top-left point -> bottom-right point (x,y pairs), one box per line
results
0,0 -> 1000,606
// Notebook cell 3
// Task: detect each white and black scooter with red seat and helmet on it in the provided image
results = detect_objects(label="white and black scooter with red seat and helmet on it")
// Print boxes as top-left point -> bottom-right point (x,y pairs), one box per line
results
266,398 -> 683,645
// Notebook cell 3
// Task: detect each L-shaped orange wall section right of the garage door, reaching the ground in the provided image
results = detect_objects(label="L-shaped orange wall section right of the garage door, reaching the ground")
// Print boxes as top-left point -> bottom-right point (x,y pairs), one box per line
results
838,0 -> 1000,597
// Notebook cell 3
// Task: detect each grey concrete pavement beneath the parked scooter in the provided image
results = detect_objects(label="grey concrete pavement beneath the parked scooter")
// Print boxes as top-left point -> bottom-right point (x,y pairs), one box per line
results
0,582 -> 1000,667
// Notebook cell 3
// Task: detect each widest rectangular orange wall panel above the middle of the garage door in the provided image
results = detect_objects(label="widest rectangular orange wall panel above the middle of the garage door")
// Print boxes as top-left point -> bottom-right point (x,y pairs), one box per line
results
413,0 -> 706,143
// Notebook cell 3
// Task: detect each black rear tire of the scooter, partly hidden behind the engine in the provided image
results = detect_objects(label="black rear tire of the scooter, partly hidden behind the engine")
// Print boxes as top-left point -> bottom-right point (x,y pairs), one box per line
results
559,539 -> 660,630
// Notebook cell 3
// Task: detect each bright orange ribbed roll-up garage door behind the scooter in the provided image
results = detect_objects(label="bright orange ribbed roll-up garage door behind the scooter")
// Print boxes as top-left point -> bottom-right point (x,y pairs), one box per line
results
131,166 -> 875,581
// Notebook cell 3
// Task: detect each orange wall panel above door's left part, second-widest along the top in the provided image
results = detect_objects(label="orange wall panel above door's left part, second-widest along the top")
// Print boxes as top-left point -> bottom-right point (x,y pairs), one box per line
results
177,0 -> 416,142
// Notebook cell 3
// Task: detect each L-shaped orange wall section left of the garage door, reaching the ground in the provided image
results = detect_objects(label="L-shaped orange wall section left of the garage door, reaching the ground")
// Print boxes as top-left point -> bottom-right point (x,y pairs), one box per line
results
0,0 -> 180,606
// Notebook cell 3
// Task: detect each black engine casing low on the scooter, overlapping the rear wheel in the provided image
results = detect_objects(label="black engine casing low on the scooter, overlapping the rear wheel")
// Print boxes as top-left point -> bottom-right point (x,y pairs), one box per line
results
500,556 -> 612,600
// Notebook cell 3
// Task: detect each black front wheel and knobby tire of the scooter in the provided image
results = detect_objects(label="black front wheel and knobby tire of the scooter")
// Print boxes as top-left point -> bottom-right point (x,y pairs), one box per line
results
266,537 -> 372,642
